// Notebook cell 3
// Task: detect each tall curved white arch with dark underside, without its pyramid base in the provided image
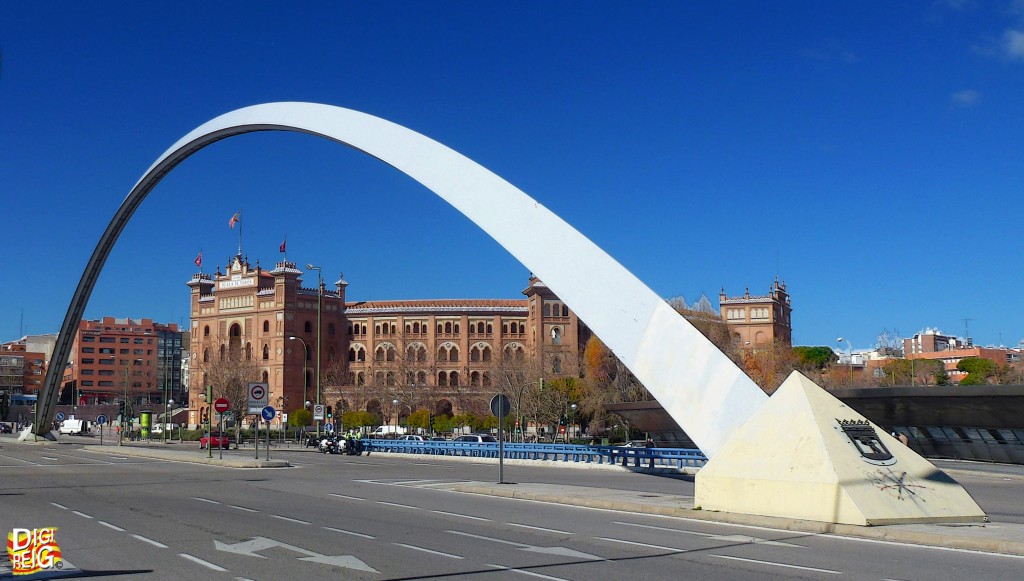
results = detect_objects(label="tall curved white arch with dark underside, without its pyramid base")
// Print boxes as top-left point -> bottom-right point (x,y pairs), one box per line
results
37,102 -> 767,457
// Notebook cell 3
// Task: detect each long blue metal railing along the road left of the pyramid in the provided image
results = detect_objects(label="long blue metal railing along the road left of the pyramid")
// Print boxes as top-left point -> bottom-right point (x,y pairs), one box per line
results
362,440 -> 708,468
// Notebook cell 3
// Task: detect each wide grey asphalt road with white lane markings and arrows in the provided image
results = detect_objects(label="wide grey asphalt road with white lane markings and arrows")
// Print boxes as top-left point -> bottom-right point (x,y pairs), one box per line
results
0,440 -> 1024,581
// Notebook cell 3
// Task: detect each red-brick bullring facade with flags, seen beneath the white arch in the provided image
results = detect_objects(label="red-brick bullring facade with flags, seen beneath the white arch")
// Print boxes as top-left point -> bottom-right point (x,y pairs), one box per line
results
187,255 -> 589,424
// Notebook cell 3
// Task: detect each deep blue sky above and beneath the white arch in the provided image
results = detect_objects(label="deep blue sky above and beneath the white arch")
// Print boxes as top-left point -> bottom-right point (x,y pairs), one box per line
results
0,0 -> 1024,348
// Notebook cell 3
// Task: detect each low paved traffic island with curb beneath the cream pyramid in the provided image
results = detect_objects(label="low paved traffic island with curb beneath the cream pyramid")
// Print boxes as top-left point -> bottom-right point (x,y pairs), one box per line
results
451,484 -> 1024,555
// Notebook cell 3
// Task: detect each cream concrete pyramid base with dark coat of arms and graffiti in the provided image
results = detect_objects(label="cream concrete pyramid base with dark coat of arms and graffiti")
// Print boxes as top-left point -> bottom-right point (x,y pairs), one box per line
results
694,372 -> 987,526
